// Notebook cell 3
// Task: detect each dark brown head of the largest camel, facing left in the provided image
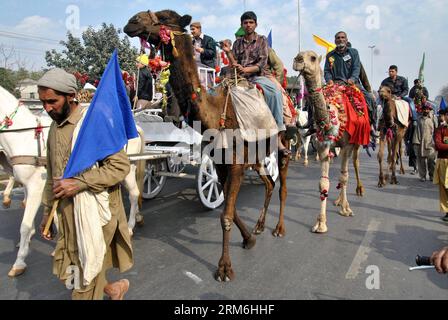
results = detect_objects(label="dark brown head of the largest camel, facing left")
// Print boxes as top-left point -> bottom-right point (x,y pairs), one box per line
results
123,10 -> 191,46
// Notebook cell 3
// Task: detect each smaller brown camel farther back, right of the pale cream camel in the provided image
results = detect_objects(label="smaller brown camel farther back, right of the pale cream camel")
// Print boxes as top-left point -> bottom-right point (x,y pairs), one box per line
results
378,86 -> 411,188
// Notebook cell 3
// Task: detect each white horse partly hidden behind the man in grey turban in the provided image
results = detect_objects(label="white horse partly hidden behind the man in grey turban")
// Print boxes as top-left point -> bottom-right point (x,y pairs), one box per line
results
0,86 -> 144,277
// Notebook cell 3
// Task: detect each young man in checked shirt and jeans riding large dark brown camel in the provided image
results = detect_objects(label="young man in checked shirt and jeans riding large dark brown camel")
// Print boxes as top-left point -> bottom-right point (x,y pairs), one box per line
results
221,11 -> 291,156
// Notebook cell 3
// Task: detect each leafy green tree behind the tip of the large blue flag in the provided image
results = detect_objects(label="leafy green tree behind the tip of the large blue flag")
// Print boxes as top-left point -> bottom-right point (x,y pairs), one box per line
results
45,23 -> 138,83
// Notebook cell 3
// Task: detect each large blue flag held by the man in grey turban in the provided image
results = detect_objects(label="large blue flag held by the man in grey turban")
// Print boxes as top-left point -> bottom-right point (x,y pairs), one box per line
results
63,50 -> 138,179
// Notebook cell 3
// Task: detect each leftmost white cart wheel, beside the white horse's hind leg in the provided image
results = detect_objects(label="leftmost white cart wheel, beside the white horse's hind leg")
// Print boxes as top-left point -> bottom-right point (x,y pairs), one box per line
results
142,160 -> 167,200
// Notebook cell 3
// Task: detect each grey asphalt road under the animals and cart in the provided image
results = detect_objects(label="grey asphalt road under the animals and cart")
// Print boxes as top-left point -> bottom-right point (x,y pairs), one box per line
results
0,154 -> 448,300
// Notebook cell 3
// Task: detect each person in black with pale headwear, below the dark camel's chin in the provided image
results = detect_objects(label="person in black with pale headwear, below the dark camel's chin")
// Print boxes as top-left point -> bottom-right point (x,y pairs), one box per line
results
135,54 -> 153,110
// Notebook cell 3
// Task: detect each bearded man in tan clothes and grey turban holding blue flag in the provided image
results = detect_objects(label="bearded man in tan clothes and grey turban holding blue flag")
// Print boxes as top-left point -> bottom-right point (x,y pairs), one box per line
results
38,69 -> 133,300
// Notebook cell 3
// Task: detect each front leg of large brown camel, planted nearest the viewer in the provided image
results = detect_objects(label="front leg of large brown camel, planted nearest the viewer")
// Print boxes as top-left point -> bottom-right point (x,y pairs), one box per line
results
215,165 -> 244,282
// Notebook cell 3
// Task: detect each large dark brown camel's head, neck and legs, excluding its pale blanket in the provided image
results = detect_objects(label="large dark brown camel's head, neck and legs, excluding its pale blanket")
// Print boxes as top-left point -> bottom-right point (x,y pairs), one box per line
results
124,10 -> 289,281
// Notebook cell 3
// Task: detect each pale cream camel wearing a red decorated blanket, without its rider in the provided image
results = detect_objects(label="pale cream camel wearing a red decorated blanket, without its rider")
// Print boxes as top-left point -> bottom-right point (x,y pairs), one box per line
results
294,51 -> 370,233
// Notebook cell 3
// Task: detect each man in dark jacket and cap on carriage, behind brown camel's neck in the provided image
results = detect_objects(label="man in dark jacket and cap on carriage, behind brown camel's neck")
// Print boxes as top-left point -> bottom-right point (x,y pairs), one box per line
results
190,22 -> 216,87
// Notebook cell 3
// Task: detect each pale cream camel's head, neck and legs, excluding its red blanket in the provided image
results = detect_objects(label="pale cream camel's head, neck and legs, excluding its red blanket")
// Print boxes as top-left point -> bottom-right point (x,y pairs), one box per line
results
293,51 -> 370,233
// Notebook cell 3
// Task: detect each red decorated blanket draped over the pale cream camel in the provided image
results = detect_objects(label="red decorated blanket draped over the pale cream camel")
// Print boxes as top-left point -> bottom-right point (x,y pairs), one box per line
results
318,85 -> 370,145
